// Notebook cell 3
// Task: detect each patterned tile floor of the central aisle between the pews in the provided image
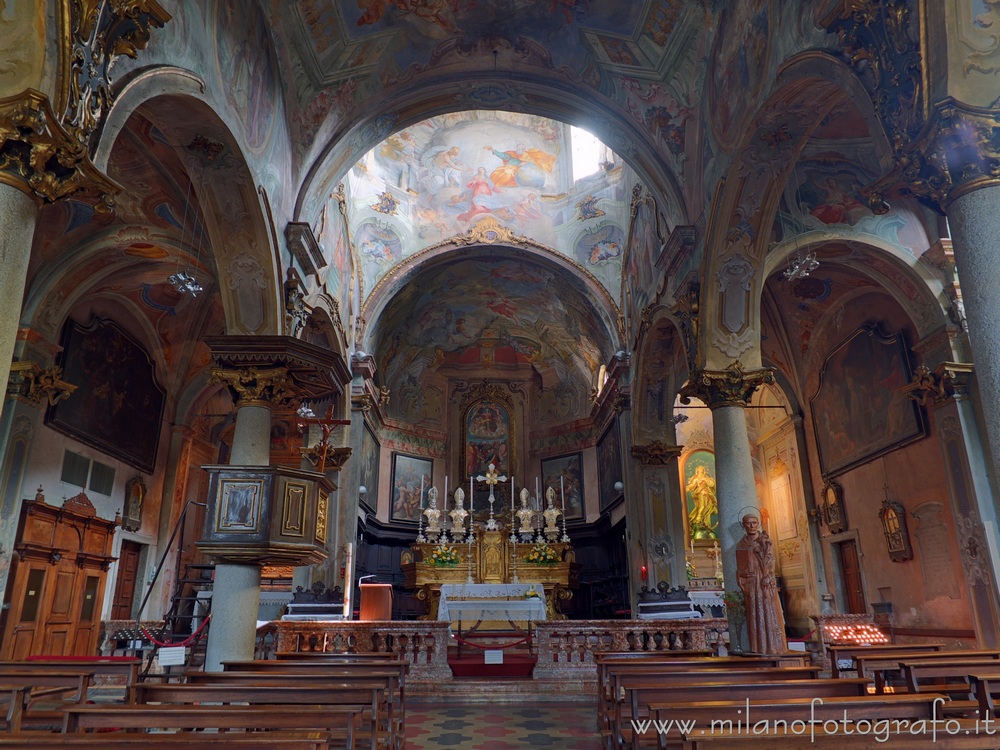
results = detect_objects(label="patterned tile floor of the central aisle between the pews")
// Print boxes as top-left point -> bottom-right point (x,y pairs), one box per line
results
405,703 -> 601,750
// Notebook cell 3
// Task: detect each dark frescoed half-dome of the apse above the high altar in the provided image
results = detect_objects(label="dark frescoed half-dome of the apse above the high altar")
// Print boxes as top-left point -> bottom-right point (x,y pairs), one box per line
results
375,258 -> 612,408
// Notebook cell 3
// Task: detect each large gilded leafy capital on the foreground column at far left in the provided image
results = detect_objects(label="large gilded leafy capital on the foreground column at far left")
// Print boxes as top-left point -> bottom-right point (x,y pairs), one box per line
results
0,89 -> 121,211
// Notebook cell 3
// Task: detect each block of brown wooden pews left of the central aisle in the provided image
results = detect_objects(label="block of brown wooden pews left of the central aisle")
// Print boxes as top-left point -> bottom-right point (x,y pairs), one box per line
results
0,654 -> 407,750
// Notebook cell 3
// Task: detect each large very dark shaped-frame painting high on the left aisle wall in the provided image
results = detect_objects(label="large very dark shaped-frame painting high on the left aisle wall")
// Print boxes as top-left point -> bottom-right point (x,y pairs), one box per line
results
45,317 -> 166,474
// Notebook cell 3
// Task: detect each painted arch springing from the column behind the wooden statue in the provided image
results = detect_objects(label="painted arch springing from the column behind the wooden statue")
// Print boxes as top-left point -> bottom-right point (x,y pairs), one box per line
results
700,51 -> 904,369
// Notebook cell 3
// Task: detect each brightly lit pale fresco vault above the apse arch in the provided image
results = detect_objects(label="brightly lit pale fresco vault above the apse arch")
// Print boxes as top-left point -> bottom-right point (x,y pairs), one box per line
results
346,111 -> 635,299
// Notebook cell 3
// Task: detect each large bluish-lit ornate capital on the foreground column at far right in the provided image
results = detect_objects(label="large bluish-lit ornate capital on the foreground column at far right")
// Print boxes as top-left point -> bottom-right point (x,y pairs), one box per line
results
864,98 -> 1000,214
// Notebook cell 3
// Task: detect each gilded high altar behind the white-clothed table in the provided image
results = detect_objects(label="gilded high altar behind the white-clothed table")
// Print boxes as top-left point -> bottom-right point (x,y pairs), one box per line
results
402,521 -> 580,620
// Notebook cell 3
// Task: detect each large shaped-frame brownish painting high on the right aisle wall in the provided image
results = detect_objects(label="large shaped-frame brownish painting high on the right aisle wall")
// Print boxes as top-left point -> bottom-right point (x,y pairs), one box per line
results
809,326 -> 927,477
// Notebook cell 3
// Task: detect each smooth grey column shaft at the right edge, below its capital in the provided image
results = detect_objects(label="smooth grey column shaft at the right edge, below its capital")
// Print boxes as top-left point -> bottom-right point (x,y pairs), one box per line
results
948,184 -> 1000,500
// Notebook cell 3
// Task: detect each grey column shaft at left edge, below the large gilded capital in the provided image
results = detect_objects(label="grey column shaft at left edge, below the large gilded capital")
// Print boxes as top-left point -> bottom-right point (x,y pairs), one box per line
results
0,187 -> 38,400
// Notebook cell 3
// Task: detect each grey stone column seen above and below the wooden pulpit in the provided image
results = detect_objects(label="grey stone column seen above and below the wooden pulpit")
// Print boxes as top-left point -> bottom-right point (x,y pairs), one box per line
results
205,384 -> 271,672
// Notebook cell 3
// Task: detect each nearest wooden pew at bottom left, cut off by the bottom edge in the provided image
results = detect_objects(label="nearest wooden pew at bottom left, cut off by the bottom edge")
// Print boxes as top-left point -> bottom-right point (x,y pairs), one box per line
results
0,732 -> 340,750
